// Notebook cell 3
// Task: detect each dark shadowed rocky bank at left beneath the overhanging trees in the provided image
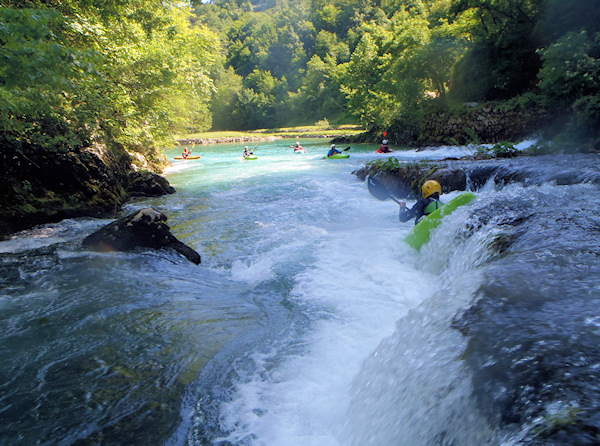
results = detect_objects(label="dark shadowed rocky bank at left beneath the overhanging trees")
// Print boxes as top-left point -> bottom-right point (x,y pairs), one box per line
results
0,137 -> 175,237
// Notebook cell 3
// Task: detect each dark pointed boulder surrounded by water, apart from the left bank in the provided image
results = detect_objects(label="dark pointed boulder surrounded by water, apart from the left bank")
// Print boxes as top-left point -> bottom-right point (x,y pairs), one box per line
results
82,208 -> 200,265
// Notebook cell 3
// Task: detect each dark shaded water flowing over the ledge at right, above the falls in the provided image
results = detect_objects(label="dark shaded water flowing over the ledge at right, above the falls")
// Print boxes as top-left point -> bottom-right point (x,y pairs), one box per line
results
453,184 -> 600,444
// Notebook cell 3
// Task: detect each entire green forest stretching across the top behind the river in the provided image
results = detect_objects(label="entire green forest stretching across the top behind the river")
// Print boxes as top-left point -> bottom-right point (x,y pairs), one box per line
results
0,0 -> 600,165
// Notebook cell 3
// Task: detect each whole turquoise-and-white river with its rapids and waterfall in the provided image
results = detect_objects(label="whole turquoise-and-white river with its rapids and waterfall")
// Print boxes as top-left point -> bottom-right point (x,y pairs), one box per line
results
0,139 -> 600,446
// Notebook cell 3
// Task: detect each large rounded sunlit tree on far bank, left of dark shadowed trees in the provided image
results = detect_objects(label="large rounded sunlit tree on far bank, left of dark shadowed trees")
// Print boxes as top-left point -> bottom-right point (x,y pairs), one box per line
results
341,1 -> 466,132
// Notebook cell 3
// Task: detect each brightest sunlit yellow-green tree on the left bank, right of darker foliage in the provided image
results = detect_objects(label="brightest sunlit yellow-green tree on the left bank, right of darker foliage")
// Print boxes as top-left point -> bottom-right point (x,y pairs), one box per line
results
98,8 -> 218,145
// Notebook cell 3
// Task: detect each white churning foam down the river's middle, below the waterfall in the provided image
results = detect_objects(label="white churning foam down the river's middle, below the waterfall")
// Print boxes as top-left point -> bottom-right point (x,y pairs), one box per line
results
216,220 -> 435,446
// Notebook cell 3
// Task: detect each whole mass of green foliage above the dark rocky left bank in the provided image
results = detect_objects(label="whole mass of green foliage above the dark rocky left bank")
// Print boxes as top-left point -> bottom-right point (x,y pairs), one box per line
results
0,0 -> 216,162
